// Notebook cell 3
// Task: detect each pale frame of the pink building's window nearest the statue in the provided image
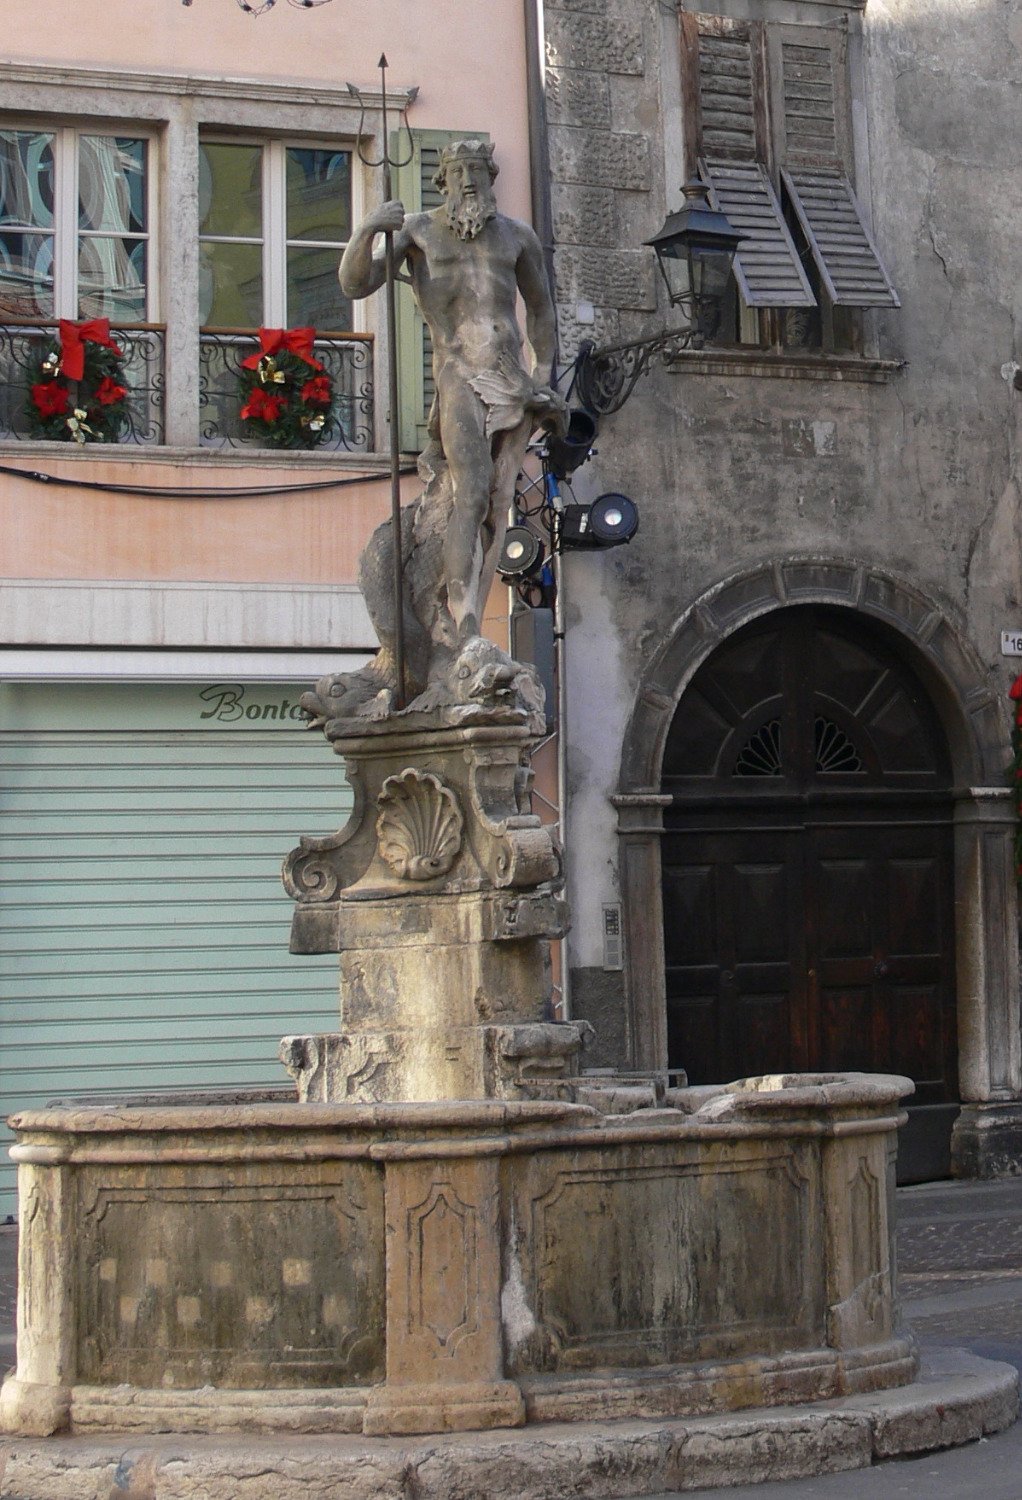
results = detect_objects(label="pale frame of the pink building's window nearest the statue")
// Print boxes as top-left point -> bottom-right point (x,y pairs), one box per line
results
197,128 -> 366,336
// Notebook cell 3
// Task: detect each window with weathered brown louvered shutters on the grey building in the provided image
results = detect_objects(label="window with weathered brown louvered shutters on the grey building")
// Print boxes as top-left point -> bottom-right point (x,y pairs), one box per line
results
680,14 -> 899,351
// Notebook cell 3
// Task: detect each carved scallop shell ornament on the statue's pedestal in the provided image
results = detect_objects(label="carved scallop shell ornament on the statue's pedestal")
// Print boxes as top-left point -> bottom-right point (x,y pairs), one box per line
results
377,770 -> 464,881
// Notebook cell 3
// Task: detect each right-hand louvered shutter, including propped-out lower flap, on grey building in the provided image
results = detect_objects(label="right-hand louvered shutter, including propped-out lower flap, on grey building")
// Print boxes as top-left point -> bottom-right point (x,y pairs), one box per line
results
768,26 -> 899,308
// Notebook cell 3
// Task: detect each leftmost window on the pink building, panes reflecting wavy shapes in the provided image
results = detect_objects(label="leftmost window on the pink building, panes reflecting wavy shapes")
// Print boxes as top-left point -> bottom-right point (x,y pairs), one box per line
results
0,128 -> 152,323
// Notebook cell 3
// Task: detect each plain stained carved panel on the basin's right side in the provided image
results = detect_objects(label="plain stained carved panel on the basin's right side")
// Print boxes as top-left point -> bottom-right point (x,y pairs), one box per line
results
512,1148 -> 824,1373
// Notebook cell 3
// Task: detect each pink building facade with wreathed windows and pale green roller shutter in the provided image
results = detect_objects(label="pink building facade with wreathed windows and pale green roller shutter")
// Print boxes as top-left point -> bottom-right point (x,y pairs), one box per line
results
0,0 -> 543,1212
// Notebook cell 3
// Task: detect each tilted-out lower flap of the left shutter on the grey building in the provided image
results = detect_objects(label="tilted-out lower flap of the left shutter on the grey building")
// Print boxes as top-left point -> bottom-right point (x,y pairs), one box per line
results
699,161 -> 816,308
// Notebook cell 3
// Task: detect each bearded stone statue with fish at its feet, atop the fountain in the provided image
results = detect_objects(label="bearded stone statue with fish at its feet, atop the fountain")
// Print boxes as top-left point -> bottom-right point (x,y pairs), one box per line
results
306,140 -> 566,725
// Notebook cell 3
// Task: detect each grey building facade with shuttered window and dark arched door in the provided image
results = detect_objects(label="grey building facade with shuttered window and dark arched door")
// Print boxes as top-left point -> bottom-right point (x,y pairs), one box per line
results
546,0 -> 1022,1175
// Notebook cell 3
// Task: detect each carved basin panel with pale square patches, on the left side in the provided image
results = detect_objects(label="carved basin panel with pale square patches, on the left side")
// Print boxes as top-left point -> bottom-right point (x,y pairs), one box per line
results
77,1163 -> 384,1389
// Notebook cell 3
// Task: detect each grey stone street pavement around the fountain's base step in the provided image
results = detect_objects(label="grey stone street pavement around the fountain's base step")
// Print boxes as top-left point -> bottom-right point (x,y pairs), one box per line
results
0,1179 -> 1022,1500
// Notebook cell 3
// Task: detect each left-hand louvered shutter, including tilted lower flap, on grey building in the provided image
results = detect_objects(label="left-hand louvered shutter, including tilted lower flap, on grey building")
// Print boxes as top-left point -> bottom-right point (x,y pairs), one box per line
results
681,14 -> 816,308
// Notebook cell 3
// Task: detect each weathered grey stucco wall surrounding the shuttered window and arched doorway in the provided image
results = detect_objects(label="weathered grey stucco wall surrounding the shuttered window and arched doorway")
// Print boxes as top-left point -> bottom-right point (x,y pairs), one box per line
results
548,0 -> 1022,1056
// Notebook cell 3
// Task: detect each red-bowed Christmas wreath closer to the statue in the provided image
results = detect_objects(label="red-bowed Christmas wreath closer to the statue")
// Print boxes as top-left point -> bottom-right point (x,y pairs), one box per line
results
240,329 -> 333,449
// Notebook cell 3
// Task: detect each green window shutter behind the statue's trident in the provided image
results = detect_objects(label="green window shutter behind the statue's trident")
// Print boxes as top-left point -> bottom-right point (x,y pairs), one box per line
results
395,131 -> 489,453
